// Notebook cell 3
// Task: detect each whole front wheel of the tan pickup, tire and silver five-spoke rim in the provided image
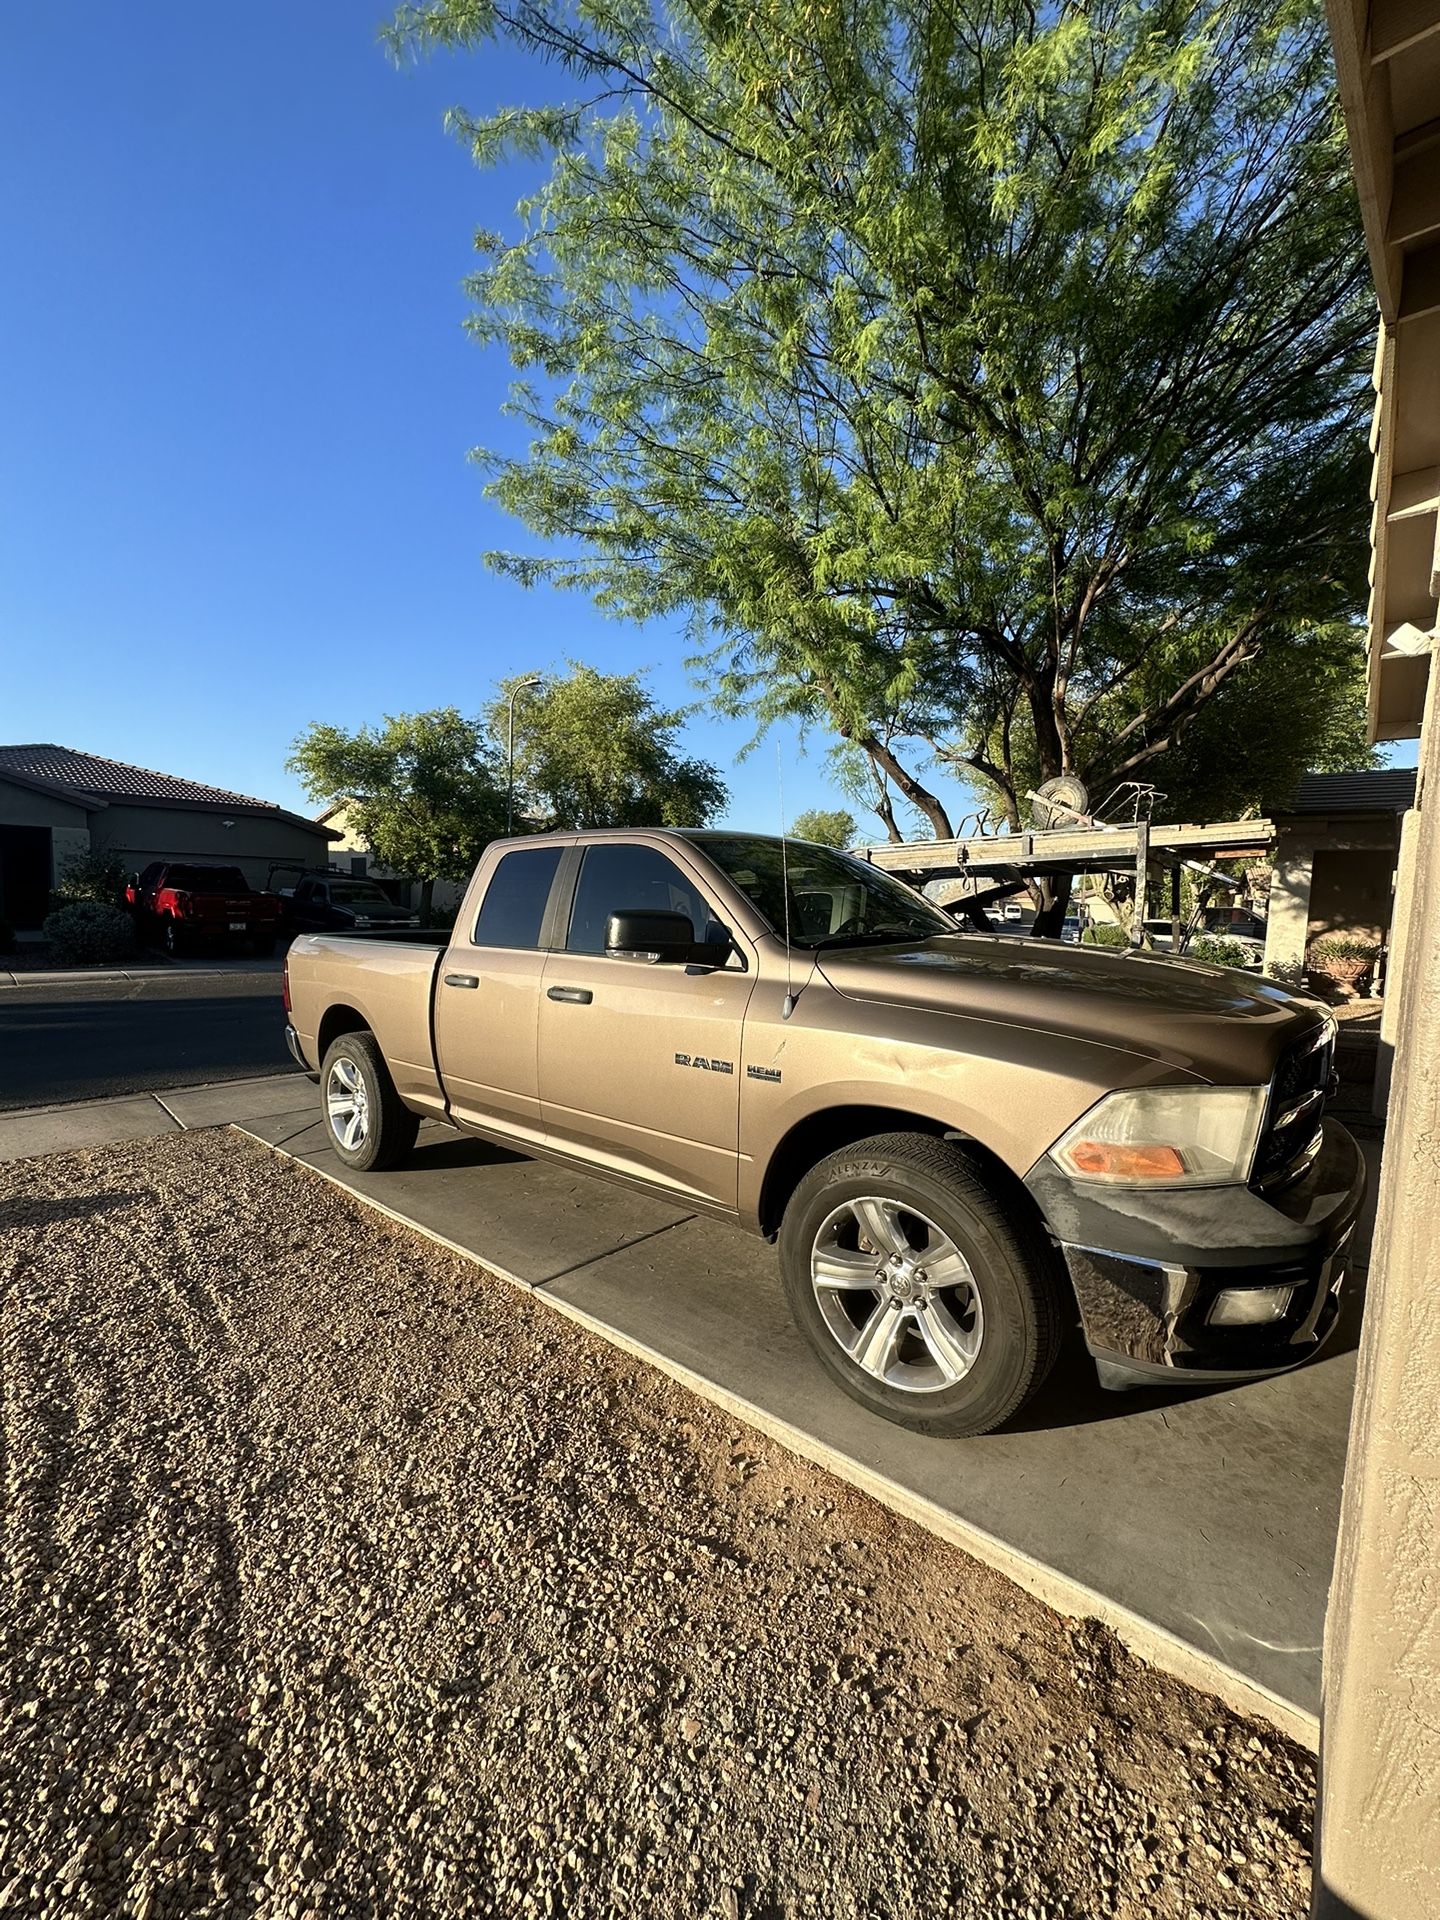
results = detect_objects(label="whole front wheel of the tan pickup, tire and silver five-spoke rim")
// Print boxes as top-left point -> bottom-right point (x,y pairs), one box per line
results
780,1133 -> 1062,1436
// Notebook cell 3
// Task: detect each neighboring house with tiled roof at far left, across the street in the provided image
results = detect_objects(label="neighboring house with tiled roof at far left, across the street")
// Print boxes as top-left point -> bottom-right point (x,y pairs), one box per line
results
0,745 -> 334,931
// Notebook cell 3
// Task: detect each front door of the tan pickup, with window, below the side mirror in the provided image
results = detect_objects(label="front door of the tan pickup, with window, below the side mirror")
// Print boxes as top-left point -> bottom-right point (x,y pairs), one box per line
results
540,841 -> 755,1208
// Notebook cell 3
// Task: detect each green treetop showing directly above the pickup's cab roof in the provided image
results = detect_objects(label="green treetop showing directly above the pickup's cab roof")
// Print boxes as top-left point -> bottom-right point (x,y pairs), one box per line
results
486,662 -> 726,828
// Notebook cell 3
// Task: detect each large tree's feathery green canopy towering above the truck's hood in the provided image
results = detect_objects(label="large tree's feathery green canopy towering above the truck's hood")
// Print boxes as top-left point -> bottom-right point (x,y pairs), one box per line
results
392,0 -> 1373,833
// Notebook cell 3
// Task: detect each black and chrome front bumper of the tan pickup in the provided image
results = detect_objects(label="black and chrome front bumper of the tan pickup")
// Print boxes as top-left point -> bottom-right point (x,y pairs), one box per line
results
1025,1119 -> 1365,1386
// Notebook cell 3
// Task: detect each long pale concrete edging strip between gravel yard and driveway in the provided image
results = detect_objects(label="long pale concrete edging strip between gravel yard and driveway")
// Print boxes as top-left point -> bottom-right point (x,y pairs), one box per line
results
232,1121 -> 1319,1753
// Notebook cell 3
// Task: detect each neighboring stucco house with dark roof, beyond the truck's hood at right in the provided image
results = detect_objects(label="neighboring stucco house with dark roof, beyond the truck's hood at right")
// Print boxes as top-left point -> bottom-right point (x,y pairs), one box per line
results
1265,768 -> 1415,979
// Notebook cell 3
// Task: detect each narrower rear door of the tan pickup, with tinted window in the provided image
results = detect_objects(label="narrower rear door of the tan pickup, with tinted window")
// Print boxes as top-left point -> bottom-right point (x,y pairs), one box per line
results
436,845 -> 564,1142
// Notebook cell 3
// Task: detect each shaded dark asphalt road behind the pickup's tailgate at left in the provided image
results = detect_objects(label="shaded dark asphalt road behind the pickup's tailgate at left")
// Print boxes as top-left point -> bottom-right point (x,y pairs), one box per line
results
0,968 -> 298,1112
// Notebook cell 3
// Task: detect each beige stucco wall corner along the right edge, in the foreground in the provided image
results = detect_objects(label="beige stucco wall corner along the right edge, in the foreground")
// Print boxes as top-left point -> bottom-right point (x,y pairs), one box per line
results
1315,676 -> 1440,1920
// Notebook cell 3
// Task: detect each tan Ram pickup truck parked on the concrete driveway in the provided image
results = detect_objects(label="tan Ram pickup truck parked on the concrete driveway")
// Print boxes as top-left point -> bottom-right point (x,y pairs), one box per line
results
284,829 -> 1365,1434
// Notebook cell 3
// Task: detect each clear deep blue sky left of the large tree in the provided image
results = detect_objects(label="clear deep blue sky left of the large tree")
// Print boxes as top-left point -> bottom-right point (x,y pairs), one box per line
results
0,0 -> 1413,826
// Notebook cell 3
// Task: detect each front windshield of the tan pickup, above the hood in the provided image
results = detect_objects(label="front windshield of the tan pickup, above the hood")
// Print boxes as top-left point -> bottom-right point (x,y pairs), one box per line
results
695,833 -> 956,950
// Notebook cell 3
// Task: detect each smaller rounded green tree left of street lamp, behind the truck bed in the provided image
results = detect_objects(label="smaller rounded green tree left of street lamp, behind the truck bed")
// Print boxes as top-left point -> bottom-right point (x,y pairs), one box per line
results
286,707 -> 505,918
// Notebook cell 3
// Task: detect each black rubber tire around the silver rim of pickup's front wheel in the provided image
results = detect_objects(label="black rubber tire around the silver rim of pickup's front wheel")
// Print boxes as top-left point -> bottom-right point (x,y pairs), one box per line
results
780,1148 -> 1039,1432
